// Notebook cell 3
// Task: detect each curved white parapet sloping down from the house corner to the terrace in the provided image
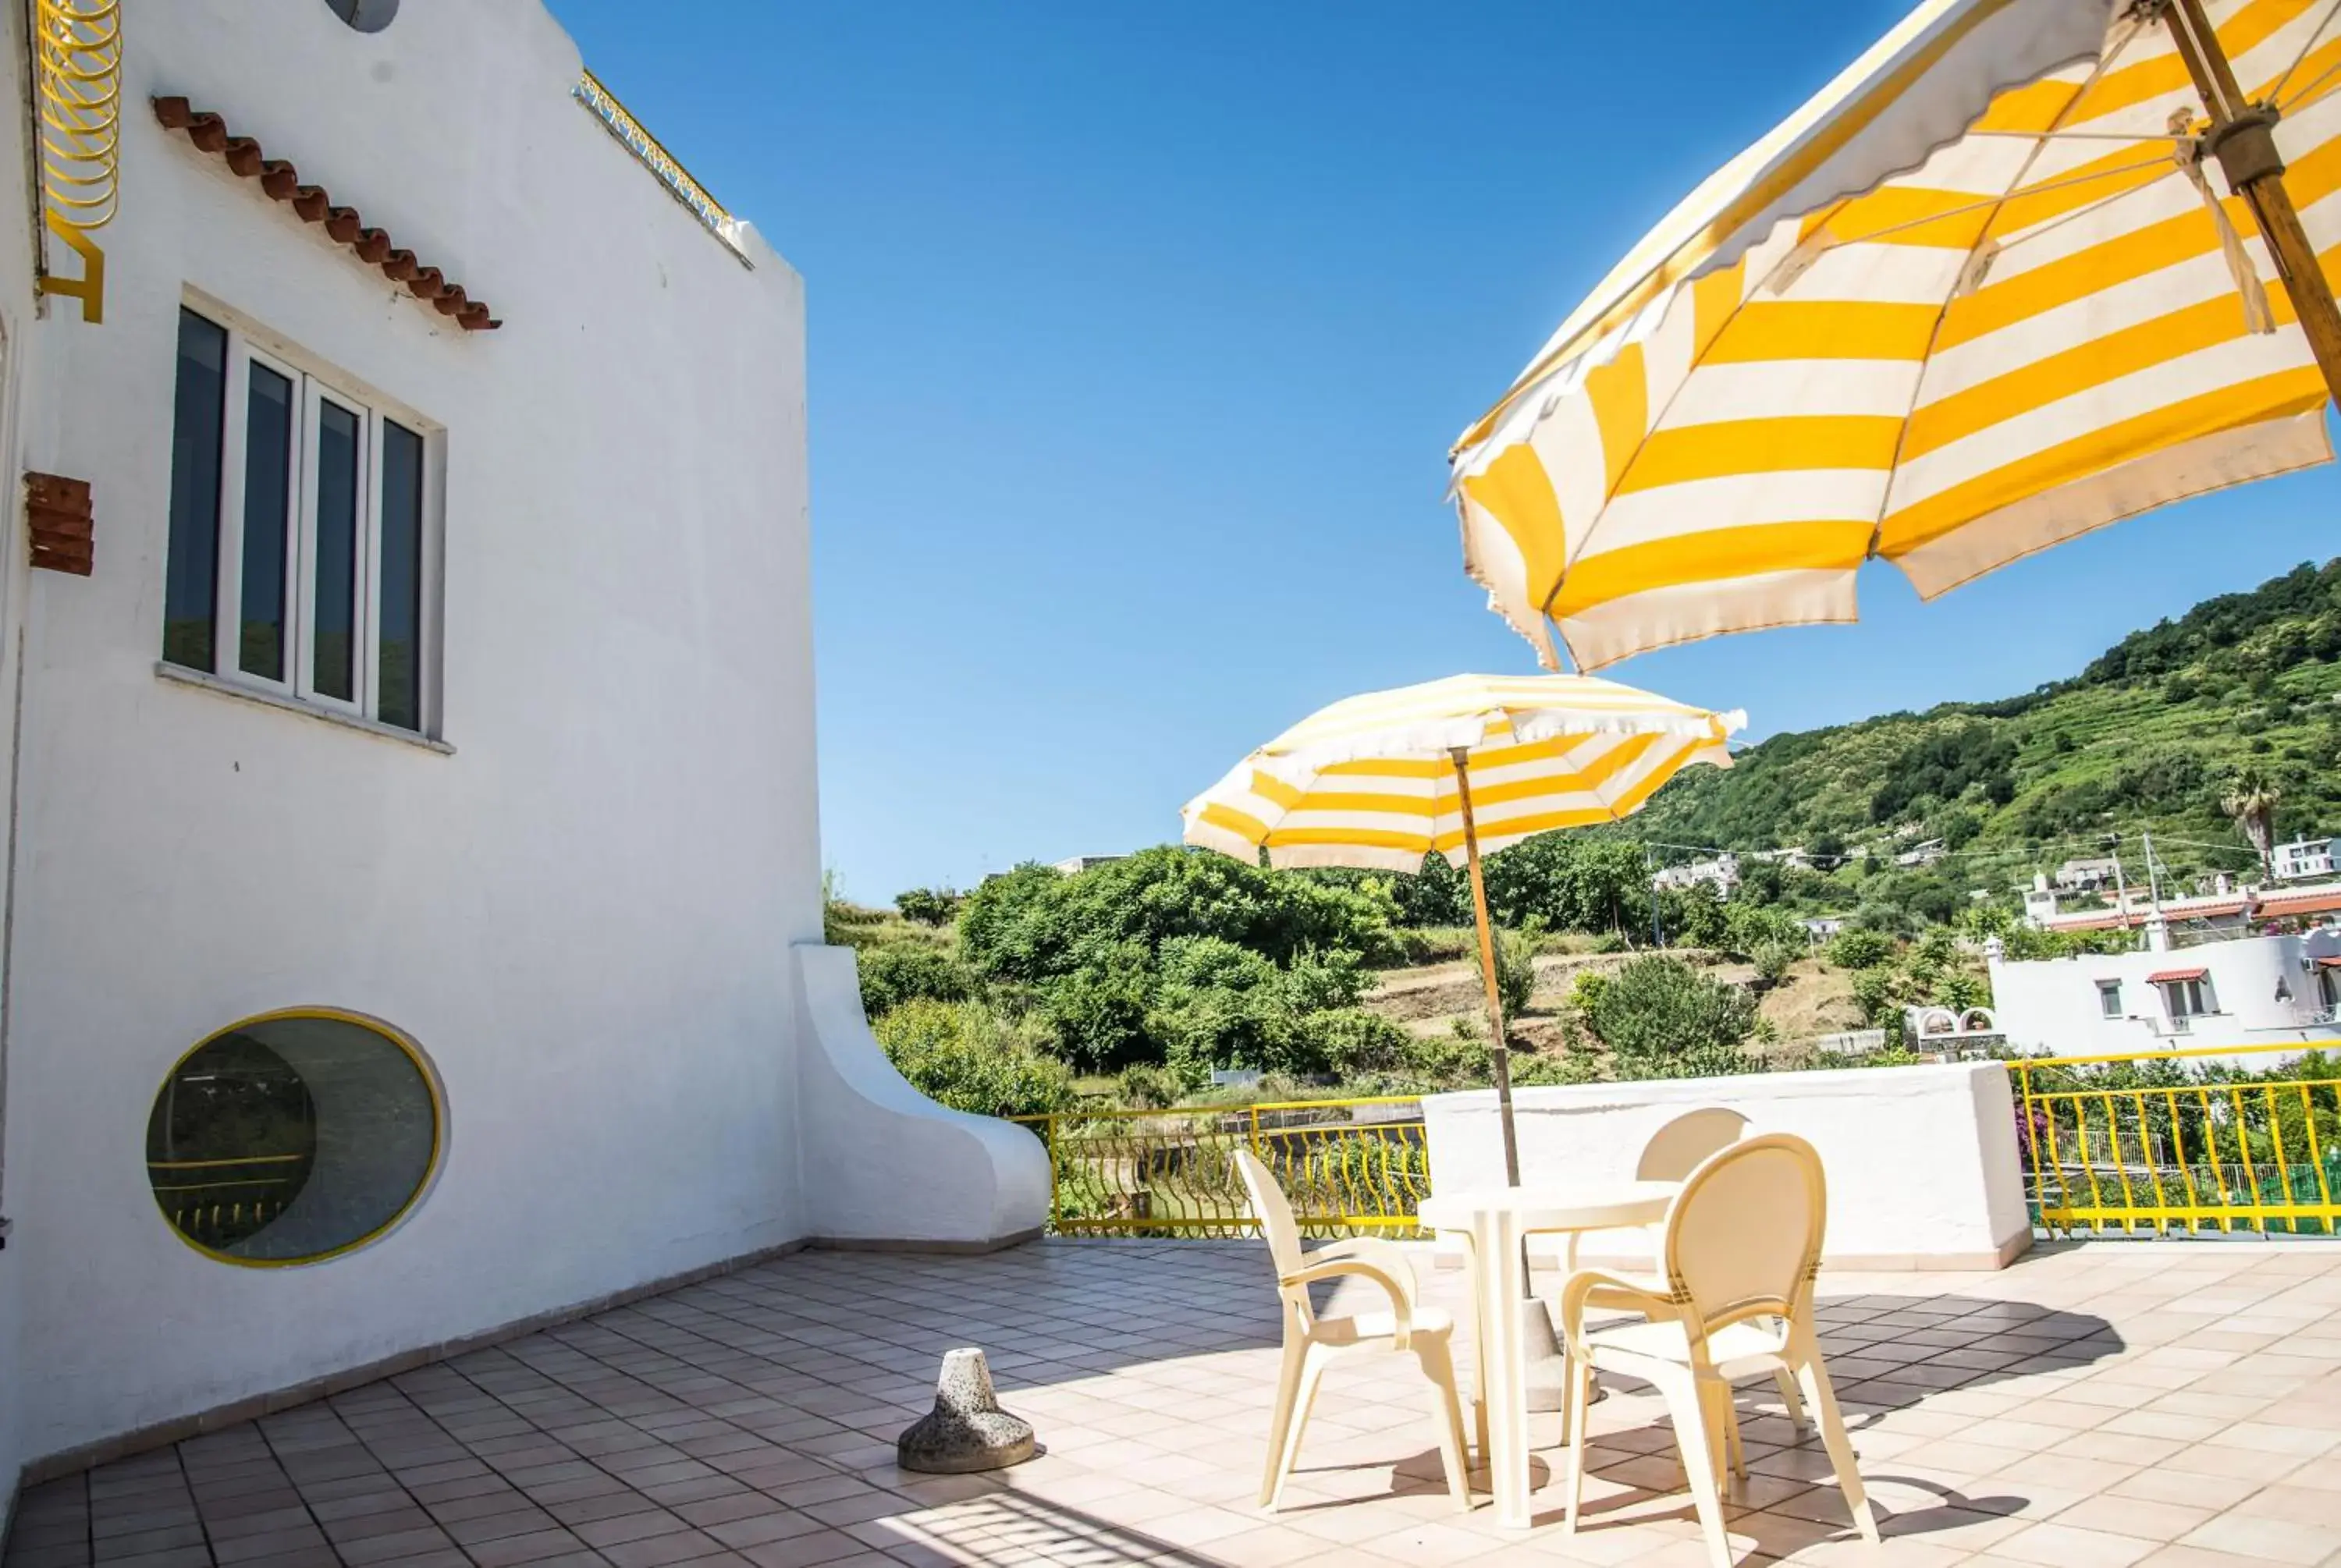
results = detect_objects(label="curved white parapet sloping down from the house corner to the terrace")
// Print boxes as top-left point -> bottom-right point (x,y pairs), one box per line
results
794,943 -> 1049,1250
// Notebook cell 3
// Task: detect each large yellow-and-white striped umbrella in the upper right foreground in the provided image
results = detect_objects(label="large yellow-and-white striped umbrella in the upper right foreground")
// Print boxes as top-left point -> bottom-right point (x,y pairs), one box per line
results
1451,0 -> 2341,669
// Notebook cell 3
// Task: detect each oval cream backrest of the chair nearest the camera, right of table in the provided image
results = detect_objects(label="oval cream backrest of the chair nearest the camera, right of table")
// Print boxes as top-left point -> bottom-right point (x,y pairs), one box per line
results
1664,1133 -> 1828,1332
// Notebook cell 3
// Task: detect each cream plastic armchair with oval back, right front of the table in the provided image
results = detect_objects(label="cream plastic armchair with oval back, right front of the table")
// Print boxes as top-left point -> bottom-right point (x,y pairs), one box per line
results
1561,1133 -> 1877,1568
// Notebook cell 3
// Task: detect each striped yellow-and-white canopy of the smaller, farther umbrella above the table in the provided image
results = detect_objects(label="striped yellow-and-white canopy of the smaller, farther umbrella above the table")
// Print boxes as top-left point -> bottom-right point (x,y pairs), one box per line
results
1185,674 -> 1746,871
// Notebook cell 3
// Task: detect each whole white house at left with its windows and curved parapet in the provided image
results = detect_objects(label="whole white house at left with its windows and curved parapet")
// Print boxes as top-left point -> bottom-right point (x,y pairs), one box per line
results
0,0 -> 1049,1507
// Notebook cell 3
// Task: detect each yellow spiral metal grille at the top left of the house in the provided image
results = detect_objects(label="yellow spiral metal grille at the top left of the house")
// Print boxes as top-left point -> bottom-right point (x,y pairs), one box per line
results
33,0 -> 122,321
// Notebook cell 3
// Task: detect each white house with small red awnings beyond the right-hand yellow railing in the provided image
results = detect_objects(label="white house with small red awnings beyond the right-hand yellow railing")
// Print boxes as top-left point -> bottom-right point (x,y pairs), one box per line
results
1985,929 -> 2341,1065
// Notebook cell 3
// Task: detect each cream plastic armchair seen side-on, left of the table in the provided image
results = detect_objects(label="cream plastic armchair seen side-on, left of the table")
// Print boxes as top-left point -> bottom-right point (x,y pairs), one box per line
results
1236,1149 -> 1470,1509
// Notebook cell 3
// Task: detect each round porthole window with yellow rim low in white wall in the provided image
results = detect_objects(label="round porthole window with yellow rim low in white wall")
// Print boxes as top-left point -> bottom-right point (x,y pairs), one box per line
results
147,1011 -> 440,1264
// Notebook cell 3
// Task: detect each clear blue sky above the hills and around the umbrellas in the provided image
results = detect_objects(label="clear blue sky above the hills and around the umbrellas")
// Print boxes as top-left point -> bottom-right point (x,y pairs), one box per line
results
550,0 -> 2341,901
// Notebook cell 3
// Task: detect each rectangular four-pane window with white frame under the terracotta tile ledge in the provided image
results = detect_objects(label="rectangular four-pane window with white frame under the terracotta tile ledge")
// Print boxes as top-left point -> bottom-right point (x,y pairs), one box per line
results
162,309 -> 433,733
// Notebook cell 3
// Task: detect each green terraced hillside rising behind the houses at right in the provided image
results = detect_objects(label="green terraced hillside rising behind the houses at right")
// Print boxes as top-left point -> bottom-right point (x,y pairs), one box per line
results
1627,559 -> 2341,917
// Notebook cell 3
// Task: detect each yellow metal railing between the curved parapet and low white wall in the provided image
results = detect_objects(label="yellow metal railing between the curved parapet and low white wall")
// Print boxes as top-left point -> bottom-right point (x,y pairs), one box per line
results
1016,1095 -> 1430,1236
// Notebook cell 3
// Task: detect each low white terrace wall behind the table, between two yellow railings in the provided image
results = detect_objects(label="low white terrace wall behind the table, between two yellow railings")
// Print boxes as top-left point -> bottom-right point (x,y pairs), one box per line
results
1423,1062 -> 2032,1268
